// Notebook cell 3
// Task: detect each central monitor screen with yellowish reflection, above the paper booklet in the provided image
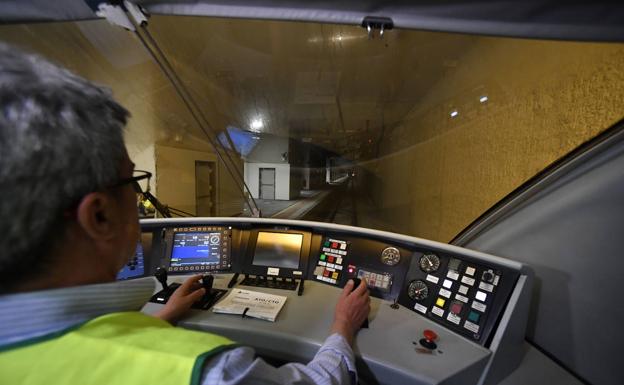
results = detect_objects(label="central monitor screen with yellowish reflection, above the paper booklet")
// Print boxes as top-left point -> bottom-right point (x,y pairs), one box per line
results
253,231 -> 303,269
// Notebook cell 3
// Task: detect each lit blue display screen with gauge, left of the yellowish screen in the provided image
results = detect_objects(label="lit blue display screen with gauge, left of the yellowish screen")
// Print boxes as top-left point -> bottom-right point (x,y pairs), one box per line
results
171,233 -> 221,266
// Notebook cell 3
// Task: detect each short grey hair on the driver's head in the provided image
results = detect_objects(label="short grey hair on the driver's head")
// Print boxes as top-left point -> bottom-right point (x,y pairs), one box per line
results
0,43 -> 129,293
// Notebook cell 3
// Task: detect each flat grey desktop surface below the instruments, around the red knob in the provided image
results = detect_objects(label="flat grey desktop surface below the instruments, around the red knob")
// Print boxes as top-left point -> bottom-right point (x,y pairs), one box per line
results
143,274 -> 491,384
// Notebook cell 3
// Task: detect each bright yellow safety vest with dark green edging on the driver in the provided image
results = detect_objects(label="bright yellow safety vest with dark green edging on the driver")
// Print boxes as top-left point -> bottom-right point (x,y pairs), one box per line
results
0,312 -> 236,385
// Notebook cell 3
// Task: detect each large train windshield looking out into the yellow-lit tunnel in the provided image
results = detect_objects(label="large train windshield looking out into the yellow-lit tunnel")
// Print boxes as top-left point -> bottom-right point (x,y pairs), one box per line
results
0,16 -> 624,242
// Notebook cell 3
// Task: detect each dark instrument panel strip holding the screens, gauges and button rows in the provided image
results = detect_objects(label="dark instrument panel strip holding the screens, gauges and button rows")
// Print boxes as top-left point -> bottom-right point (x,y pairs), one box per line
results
130,222 -> 520,345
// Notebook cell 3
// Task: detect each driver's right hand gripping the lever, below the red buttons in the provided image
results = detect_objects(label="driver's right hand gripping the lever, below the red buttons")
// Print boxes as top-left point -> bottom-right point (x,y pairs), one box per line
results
331,279 -> 370,345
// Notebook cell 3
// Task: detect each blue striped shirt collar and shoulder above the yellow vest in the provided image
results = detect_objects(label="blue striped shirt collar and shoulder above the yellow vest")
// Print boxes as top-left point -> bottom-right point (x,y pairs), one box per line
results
0,277 -> 156,346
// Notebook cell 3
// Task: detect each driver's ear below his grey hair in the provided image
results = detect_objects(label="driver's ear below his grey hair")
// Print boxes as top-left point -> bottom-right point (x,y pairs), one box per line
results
76,192 -> 115,240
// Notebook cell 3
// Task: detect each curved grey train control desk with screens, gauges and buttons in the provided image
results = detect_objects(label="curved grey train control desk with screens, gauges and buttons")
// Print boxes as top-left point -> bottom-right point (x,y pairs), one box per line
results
132,218 -> 532,384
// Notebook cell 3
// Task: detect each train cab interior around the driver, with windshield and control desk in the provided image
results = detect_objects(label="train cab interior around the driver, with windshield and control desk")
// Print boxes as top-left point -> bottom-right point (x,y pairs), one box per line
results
0,0 -> 624,385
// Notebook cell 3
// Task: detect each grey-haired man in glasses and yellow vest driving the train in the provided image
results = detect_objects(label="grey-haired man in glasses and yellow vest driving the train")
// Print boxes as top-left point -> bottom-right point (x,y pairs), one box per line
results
0,45 -> 370,384
